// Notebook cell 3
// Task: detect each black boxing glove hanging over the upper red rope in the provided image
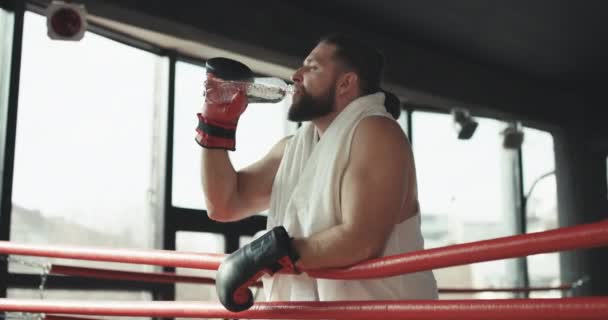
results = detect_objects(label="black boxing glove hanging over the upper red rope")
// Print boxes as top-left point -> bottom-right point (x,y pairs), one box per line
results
215,227 -> 300,312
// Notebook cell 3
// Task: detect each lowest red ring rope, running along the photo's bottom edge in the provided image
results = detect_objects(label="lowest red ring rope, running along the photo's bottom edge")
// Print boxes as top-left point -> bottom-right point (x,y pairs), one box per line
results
0,297 -> 608,320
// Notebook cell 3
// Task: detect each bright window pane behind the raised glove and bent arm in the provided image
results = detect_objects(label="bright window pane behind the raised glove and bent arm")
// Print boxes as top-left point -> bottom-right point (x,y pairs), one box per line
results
173,62 -> 294,209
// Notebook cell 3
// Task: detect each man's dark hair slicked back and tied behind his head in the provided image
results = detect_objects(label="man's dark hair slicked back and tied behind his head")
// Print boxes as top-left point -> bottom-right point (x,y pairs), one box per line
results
319,33 -> 401,119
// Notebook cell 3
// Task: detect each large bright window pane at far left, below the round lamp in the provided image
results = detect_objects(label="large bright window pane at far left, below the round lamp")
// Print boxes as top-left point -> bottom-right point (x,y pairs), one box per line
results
10,12 -> 167,272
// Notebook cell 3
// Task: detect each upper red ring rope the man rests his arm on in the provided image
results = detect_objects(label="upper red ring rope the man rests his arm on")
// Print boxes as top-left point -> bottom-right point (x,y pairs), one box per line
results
0,220 -> 608,279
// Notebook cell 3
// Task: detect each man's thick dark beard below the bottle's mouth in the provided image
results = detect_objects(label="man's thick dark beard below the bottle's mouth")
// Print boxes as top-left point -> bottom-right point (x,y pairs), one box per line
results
287,84 -> 336,122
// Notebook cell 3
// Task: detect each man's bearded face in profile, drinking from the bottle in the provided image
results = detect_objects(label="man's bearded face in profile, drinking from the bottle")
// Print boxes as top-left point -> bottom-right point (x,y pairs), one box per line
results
287,43 -> 338,121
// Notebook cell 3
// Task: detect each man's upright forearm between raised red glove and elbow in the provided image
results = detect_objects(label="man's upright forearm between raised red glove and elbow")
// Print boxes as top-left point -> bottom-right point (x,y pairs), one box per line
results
201,148 -> 237,215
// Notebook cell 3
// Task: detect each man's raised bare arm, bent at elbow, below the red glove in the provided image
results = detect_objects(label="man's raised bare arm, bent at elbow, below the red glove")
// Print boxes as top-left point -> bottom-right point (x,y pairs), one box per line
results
201,137 -> 289,222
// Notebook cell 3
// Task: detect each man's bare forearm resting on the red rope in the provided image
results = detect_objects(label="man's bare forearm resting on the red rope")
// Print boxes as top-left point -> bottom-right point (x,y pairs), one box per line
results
293,225 -> 380,269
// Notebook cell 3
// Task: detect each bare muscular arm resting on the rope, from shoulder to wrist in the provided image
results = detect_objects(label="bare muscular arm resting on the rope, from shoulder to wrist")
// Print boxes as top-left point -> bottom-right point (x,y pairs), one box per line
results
294,117 -> 413,269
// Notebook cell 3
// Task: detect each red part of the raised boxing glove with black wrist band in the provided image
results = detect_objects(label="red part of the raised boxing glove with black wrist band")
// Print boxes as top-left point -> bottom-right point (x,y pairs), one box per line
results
196,74 -> 248,151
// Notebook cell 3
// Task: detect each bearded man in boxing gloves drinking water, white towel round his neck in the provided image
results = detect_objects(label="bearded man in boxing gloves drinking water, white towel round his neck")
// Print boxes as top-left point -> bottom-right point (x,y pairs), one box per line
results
197,35 -> 437,311
